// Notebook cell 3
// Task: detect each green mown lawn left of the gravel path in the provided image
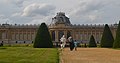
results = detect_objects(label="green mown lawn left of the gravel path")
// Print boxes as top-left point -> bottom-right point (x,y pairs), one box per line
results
0,47 -> 59,63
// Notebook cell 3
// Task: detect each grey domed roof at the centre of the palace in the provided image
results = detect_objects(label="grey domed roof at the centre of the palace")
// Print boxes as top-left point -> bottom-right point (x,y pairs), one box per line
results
51,12 -> 71,25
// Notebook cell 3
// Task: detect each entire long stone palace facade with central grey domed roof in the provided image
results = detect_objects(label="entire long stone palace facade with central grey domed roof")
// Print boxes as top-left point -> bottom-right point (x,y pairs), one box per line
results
0,12 -> 117,44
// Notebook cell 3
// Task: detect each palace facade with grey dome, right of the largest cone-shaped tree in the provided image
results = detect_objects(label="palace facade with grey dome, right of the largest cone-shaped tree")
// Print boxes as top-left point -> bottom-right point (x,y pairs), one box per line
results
49,12 -> 117,43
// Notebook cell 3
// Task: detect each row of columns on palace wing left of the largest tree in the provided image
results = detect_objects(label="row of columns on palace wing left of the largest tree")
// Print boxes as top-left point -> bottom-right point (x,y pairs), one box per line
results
0,30 -> 36,40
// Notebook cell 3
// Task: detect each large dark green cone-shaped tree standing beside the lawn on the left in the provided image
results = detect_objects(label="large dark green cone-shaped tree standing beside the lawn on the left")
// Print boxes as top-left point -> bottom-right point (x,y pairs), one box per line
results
33,23 -> 53,48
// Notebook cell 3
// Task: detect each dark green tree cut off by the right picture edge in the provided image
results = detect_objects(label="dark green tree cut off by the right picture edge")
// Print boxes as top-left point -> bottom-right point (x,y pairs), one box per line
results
113,21 -> 120,48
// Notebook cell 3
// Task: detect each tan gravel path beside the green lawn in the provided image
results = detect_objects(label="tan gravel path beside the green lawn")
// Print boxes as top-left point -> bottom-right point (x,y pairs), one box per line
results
60,48 -> 120,63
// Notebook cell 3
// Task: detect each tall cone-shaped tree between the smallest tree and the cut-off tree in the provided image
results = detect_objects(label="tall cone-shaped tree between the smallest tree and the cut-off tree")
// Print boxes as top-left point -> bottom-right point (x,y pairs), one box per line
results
100,24 -> 114,48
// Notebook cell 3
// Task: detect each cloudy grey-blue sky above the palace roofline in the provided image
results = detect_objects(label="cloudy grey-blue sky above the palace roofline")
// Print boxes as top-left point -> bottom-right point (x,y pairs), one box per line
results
0,0 -> 120,24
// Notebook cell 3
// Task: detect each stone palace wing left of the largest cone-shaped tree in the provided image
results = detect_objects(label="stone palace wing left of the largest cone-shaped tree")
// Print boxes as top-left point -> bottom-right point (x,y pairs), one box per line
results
0,23 -> 39,44
